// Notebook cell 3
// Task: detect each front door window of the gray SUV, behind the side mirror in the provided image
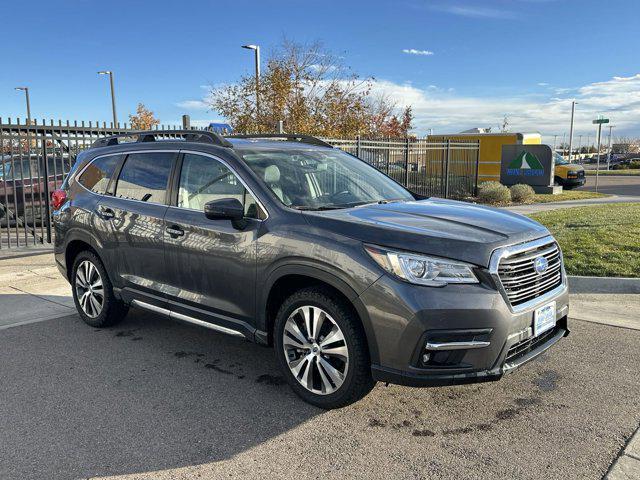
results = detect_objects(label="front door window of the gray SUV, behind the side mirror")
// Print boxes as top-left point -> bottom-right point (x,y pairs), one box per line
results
178,153 -> 263,218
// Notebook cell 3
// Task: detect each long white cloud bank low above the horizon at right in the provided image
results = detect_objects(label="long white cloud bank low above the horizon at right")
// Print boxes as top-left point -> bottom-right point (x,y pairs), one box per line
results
364,74 -> 640,139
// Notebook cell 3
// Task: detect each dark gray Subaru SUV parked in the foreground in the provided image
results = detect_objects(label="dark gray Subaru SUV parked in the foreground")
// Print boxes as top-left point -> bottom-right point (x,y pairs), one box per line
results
53,131 -> 569,408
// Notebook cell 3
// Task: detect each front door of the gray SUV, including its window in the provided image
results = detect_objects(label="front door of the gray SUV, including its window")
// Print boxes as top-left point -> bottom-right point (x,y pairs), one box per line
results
164,153 -> 265,331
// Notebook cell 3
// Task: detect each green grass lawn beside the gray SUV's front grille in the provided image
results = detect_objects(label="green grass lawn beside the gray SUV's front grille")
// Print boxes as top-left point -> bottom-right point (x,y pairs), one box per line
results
530,203 -> 640,277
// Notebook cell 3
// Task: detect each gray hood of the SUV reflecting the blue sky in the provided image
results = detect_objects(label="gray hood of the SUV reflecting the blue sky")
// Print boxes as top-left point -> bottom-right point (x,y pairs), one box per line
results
305,199 -> 549,267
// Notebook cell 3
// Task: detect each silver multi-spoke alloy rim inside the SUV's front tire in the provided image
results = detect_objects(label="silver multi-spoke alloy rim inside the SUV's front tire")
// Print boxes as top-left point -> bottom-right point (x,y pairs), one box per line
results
282,305 -> 349,395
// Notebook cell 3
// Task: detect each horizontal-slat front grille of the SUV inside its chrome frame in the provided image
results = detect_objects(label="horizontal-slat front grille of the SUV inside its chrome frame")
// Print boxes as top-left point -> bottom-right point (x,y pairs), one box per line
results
498,241 -> 562,307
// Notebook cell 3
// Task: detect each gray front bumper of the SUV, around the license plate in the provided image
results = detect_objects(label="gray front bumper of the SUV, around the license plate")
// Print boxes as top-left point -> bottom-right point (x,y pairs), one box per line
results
360,275 -> 569,386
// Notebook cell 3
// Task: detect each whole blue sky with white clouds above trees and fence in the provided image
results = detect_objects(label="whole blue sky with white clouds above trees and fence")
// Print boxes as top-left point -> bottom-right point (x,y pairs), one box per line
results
0,0 -> 640,139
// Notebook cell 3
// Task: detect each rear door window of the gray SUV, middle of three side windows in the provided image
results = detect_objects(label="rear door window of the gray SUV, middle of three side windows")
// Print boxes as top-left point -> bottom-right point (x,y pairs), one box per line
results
116,152 -> 176,203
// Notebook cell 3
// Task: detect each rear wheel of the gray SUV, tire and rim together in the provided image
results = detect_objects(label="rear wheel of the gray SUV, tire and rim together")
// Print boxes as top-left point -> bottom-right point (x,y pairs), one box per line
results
71,250 -> 128,328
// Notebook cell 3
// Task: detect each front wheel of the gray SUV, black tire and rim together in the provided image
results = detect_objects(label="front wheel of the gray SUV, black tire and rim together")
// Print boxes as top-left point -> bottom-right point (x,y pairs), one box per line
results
274,287 -> 375,409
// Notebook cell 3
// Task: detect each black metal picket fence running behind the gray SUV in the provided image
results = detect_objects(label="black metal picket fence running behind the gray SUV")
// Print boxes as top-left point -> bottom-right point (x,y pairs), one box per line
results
0,118 -> 479,249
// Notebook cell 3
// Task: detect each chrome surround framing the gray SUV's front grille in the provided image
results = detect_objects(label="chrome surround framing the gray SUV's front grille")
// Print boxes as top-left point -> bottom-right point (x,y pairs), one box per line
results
489,235 -> 567,313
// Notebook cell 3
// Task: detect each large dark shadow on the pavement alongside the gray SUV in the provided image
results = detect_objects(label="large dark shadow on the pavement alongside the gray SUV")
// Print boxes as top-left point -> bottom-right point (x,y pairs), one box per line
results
0,310 -> 321,479
